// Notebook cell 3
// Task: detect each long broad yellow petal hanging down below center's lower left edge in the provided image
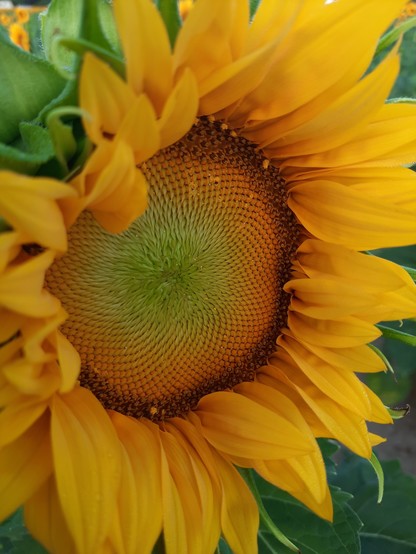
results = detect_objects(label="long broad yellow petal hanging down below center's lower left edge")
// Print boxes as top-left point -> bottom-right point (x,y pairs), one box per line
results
51,387 -> 120,554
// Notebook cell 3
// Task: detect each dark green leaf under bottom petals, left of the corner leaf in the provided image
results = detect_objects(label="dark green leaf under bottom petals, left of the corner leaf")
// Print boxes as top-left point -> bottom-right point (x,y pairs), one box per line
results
256,477 -> 362,554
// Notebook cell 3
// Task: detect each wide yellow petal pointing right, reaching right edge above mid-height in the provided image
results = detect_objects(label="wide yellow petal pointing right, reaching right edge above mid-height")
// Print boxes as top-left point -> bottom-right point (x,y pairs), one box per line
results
288,181 -> 416,250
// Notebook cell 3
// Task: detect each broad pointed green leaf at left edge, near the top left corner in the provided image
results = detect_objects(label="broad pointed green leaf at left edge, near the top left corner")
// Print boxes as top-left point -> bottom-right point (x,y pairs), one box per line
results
0,29 -> 65,143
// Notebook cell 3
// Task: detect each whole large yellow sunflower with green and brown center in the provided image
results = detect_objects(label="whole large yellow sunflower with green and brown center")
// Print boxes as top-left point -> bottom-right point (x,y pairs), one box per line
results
0,0 -> 416,554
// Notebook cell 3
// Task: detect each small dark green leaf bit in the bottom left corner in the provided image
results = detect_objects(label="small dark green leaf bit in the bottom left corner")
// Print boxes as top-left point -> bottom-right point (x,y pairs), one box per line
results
0,510 -> 47,554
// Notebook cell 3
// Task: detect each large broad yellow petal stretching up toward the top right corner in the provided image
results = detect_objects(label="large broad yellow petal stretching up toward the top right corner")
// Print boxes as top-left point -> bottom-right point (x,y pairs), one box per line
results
239,0 -> 406,120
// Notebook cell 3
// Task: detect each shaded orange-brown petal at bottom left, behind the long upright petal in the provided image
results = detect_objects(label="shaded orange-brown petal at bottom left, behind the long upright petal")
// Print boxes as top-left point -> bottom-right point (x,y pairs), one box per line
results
24,477 -> 75,554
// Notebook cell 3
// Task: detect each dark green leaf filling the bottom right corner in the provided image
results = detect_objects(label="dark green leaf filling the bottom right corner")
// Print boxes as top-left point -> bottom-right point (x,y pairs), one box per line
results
336,456 -> 416,554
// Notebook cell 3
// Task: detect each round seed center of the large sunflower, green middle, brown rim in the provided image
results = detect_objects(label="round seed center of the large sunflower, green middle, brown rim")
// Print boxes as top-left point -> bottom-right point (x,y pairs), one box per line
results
46,120 -> 298,420
